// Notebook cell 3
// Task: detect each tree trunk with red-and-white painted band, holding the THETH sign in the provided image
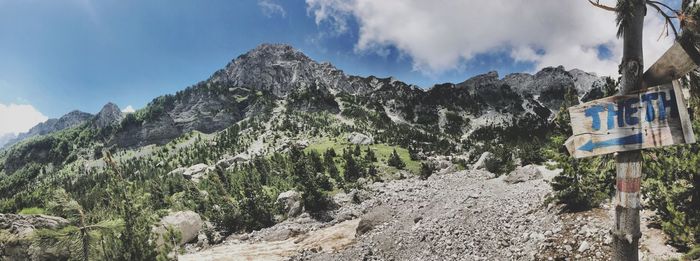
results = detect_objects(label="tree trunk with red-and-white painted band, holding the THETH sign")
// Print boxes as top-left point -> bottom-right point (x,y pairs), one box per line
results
612,0 -> 646,261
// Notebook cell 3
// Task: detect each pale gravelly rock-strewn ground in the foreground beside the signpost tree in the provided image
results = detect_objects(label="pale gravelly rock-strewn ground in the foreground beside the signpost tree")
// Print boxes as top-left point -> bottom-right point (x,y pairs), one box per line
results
179,166 -> 678,260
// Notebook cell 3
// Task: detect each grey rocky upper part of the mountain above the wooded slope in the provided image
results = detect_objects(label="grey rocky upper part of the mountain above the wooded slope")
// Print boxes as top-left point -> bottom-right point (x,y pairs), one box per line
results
0,44 -> 606,177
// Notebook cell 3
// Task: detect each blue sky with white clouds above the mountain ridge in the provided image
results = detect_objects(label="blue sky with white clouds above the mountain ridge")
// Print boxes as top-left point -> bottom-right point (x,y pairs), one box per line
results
0,0 -> 680,135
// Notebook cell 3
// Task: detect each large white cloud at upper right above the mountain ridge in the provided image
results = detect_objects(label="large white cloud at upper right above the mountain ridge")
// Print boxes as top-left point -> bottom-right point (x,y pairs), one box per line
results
306,0 -> 673,75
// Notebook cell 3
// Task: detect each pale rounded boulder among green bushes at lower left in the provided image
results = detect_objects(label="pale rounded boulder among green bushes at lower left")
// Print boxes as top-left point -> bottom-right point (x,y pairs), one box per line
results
151,210 -> 204,247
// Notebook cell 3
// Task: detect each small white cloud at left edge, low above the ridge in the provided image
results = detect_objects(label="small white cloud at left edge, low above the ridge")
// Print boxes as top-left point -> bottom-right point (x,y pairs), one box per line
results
0,103 -> 48,136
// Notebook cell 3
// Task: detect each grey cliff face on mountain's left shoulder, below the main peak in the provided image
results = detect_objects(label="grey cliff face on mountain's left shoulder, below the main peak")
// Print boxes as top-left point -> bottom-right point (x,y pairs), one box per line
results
109,82 -> 266,147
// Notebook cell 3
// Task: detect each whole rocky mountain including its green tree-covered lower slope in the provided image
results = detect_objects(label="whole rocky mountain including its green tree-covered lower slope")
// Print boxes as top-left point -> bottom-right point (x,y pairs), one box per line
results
0,44 -> 614,260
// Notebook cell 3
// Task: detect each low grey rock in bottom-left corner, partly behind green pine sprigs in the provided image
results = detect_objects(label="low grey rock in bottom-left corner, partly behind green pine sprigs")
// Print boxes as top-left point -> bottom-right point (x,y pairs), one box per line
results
0,214 -> 70,260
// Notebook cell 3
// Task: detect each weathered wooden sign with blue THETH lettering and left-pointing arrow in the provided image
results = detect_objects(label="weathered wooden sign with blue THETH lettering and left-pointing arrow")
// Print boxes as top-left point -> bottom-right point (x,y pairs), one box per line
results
566,81 -> 695,158
